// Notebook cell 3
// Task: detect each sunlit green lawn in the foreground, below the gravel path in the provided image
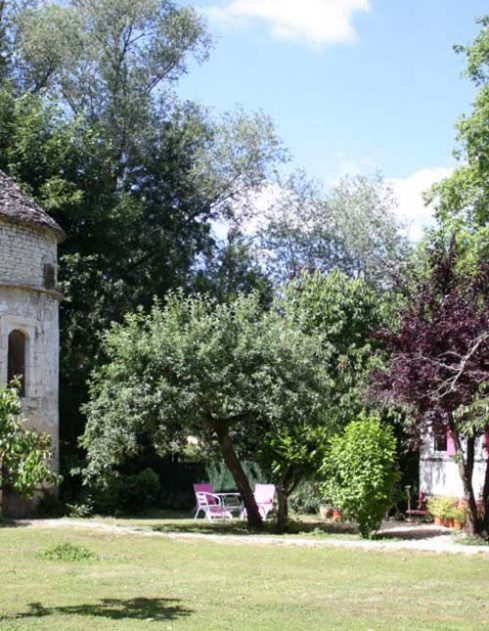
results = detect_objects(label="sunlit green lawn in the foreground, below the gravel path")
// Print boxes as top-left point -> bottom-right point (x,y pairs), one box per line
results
0,527 -> 489,631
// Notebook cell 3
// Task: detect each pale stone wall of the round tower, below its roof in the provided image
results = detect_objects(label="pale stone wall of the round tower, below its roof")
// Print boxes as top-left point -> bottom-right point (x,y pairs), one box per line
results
0,219 -> 60,515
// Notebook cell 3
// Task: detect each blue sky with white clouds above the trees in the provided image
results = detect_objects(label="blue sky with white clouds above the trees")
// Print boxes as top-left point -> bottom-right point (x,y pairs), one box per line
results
179,0 -> 489,237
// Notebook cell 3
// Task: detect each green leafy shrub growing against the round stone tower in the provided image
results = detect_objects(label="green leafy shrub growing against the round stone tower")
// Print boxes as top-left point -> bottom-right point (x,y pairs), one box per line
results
0,387 -> 59,503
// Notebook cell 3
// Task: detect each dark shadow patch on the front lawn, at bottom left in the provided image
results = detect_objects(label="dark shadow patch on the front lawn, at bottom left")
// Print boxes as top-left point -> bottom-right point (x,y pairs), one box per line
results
12,598 -> 193,622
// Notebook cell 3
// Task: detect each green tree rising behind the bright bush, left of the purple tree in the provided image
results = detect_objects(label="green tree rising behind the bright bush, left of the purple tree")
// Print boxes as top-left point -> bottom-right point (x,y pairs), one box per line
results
285,270 -> 390,428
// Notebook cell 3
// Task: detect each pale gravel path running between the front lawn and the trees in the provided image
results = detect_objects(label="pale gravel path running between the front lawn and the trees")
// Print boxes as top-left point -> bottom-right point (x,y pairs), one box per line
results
10,519 -> 489,558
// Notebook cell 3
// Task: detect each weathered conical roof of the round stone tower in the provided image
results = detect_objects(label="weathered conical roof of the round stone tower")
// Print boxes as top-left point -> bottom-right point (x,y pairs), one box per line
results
0,171 -> 66,240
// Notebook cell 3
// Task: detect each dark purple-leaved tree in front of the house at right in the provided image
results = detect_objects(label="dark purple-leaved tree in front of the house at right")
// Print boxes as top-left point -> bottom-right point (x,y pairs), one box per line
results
376,244 -> 489,532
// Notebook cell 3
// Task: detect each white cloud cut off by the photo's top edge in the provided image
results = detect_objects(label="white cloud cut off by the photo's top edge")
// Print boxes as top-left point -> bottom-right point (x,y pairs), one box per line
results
205,0 -> 371,48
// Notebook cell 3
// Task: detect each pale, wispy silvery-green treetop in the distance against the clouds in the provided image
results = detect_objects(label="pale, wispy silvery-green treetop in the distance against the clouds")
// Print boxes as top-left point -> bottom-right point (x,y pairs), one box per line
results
260,174 -> 409,288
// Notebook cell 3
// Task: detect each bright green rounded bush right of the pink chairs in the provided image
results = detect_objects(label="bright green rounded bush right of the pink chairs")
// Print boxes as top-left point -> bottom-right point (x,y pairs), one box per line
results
324,415 -> 400,537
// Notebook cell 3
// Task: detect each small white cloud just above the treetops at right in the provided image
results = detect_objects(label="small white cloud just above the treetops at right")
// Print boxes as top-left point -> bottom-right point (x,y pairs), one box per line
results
389,167 -> 453,241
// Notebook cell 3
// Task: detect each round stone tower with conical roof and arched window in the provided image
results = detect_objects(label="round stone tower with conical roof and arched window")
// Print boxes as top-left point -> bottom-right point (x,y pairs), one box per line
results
0,171 -> 64,516
